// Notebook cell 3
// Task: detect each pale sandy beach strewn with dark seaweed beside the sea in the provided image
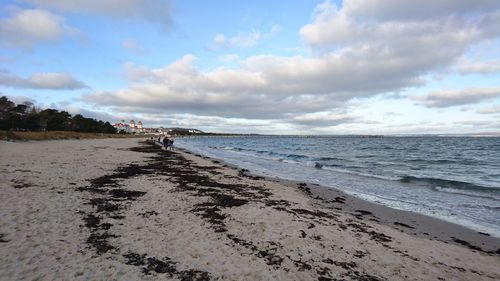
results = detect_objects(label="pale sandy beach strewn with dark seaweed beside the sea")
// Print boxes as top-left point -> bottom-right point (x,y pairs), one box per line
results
0,139 -> 500,280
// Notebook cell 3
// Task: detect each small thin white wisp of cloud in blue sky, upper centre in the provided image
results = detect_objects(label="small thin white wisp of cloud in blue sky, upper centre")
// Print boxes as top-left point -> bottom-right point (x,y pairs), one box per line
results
213,24 -> 281,48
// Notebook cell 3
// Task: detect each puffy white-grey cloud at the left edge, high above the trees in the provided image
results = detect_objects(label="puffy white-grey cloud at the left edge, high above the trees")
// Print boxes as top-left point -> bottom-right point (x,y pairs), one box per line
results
0,9 -> 78,49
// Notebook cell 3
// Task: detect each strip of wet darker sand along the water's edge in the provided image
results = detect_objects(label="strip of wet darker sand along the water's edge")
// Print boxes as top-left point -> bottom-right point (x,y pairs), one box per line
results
176,145 -> 500,255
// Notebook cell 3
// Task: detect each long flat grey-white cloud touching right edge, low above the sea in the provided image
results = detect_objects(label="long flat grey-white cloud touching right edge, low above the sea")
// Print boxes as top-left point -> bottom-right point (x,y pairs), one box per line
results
414,87 -> 500,107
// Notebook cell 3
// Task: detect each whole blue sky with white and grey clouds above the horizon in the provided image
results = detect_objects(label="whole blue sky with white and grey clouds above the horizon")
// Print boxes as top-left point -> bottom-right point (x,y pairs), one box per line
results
0,0 -> 500,134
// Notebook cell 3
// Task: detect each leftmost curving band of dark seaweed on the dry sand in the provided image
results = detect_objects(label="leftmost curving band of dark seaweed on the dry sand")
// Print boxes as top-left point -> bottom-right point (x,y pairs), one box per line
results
77,142 -> 213,281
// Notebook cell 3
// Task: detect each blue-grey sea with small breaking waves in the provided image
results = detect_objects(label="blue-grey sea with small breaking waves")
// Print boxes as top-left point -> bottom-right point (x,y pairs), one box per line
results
176,136 -> 500,237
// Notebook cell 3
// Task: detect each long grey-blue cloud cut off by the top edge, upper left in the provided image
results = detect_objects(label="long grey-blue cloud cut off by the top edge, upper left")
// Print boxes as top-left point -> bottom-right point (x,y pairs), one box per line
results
24,0 -> 171,28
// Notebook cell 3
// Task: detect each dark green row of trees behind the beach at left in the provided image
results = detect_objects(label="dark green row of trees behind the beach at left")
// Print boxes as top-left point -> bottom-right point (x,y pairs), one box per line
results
0,96 -> 116,134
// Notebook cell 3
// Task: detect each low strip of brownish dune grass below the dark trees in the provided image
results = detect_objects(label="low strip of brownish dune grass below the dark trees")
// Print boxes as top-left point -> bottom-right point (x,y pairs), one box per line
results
0,131 -> 145,141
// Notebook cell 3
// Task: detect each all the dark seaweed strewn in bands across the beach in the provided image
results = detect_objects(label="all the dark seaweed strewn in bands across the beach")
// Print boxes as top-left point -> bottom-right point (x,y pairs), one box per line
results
79,143 -> 402,281
